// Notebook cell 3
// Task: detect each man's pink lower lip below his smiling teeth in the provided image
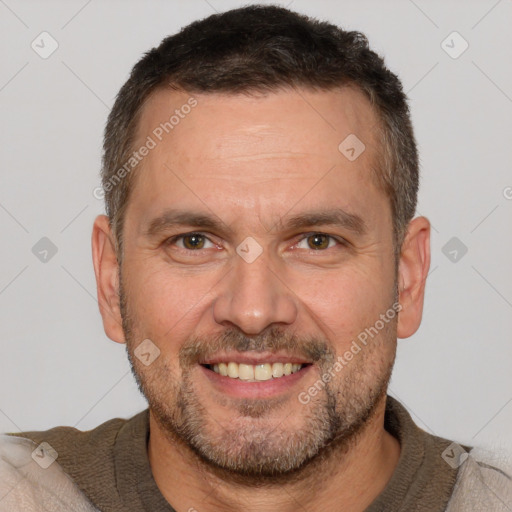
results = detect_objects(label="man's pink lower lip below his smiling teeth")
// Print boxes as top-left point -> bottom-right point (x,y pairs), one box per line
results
199,365 -> 313,398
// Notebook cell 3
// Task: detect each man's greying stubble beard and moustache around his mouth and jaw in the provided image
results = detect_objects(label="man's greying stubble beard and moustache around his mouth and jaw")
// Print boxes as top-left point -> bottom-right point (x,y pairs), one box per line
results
120,279 -> 396,485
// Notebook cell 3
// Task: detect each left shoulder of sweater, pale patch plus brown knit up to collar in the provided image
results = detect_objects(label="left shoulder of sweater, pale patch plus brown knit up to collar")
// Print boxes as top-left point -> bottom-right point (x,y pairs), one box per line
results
0,410 -> 147,512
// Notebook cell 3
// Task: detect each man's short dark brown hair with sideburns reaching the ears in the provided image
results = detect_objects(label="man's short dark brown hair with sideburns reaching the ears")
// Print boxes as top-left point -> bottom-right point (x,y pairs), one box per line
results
102,5 -> 419,261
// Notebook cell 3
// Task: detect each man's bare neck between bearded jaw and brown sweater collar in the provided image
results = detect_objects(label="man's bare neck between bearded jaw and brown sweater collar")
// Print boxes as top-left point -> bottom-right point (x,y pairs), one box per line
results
148,395 -> 400,512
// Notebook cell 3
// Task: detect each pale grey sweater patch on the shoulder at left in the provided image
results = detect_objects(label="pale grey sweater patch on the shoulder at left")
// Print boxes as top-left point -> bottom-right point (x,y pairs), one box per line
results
0,434 -> 97,512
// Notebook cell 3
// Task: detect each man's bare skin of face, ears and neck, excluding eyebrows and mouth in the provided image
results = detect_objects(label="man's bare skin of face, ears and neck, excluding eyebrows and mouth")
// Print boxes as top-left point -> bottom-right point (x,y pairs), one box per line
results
92,88 -> 430,512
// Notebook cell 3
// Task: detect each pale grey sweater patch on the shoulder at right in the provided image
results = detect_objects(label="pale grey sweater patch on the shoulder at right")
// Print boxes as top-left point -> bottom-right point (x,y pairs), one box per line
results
447,448 -> 512,512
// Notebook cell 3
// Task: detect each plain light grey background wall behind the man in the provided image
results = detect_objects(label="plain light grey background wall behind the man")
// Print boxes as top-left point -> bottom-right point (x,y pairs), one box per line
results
0,0 -> 512,449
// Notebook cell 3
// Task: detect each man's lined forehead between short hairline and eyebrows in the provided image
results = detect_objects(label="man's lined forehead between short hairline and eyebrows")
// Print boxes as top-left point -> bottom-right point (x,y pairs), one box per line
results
127,87 -> 380,228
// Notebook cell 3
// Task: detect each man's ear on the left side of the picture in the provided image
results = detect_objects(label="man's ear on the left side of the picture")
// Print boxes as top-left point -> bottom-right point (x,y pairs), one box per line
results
92,215 -> 125,343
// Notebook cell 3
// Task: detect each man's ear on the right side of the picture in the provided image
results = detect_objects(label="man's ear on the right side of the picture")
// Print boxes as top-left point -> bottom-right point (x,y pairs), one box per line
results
397,217 -> 430,338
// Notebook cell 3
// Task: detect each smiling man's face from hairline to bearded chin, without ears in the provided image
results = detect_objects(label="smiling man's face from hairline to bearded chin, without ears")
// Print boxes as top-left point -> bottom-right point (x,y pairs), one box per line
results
121,88 -> 396,476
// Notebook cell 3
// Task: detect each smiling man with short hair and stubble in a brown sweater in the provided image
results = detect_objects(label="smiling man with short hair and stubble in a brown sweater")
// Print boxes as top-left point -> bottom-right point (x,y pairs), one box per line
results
0,6 -> 512,512
